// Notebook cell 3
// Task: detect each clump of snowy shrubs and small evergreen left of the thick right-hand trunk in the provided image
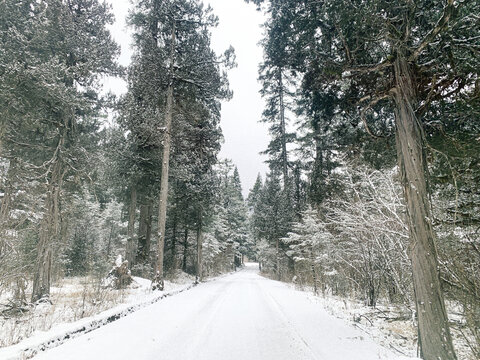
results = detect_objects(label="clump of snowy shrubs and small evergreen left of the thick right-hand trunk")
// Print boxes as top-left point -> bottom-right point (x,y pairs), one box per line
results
282,167 -> 411,306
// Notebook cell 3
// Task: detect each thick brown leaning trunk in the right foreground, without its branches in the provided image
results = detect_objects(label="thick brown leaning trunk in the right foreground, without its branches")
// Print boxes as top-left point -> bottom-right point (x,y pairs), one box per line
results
395,52 -> 456,360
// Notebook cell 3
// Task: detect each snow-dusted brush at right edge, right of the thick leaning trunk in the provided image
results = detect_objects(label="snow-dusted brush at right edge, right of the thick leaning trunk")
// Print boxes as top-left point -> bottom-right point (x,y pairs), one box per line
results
433,162 -> 480,356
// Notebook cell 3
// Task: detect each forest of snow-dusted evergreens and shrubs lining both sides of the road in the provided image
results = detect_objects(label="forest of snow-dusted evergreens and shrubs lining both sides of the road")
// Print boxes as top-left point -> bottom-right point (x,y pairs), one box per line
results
0,0 -> 480,360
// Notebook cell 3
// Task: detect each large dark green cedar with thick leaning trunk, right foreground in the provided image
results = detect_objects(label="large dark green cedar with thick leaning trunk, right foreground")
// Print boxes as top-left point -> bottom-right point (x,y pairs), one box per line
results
248,0 -> 480,359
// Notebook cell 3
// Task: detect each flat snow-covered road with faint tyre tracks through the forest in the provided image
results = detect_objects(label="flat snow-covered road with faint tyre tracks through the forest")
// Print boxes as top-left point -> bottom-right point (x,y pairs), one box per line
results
35,264 -> 412,360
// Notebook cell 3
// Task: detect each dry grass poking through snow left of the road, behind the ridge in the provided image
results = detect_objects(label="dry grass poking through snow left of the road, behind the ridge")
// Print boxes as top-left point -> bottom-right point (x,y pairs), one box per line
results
0,272 -> 194,347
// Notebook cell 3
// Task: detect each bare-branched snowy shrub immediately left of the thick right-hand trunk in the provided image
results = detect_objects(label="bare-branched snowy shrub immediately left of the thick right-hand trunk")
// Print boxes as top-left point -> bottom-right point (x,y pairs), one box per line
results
325,167 -> 411,306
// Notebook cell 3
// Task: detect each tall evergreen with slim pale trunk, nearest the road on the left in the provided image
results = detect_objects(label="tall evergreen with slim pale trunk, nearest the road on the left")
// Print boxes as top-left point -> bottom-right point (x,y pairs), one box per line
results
126,0 -> 233,289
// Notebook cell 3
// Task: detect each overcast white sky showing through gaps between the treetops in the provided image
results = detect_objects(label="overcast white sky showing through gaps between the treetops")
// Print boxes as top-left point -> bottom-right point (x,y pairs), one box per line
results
105,0 -> 269,195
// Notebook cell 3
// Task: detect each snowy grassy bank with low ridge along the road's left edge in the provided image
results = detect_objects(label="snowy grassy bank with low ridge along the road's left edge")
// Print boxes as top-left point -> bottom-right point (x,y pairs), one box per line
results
0,273 -> 196,360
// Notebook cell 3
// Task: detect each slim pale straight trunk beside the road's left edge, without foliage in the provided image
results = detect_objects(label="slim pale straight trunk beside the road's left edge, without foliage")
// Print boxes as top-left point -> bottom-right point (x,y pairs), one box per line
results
152,20 -> 176,290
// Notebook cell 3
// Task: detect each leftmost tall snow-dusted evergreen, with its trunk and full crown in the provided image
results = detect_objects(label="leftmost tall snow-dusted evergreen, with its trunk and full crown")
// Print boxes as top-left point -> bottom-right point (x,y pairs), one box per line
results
0,0 -> 118,301
